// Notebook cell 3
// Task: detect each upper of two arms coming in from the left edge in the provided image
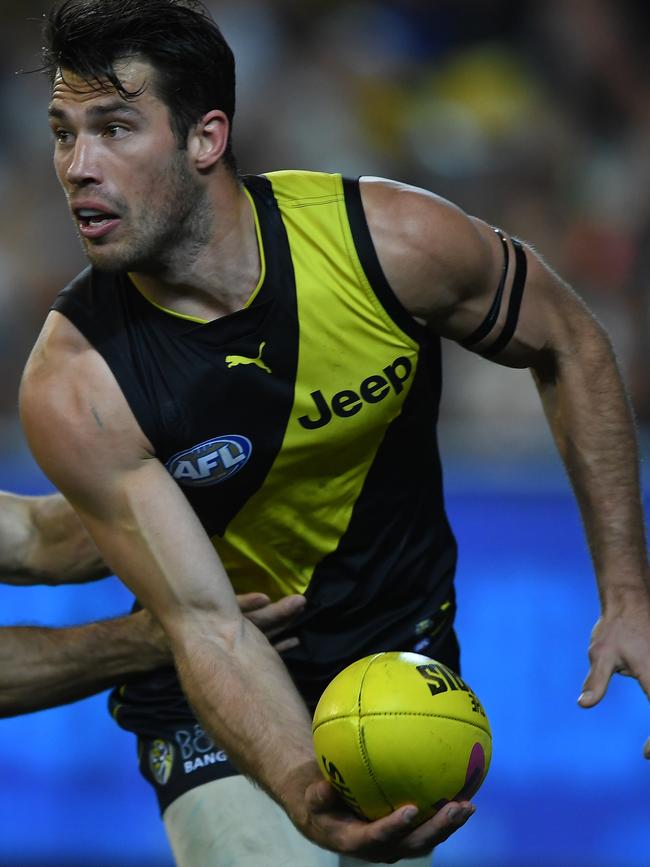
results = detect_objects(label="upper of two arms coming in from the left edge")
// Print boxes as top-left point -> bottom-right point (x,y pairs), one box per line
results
0,492 -> 109,585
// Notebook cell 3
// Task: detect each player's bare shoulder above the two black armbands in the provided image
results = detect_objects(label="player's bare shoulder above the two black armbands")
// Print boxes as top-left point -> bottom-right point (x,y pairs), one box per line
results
360,177 -> 498,320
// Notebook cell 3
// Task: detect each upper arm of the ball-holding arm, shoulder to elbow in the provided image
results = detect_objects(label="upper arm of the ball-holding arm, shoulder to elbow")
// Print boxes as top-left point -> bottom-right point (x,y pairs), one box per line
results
20,313 -> 239,634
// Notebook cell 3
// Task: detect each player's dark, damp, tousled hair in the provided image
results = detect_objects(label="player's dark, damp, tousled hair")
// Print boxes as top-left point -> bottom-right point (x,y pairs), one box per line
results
43,0 -> 237,174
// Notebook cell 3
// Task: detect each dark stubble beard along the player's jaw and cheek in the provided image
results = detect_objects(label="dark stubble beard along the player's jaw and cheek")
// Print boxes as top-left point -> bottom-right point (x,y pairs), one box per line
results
81,151 -> 212,277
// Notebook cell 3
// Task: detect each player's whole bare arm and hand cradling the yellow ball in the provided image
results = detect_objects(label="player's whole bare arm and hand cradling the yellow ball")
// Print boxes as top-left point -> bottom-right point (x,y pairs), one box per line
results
21,313 -> 469,861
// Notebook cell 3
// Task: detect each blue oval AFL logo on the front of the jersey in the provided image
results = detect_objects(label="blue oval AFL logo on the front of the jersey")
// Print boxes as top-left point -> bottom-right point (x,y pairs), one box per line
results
165,434 -> 253,487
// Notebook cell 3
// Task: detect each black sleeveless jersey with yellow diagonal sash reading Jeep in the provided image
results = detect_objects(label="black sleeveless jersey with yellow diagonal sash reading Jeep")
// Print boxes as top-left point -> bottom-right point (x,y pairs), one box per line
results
53,172 -> 456,721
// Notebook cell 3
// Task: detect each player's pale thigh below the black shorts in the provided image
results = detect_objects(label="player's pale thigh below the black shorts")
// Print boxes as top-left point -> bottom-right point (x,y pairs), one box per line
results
164,776 -> 431,867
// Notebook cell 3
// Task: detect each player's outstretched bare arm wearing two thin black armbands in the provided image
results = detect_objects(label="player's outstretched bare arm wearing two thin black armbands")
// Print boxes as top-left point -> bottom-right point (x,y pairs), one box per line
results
362,179 -> 650,732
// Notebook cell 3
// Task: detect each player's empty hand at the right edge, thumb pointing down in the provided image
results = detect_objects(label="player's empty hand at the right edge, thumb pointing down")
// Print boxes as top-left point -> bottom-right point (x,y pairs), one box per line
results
578,588 -> 650,759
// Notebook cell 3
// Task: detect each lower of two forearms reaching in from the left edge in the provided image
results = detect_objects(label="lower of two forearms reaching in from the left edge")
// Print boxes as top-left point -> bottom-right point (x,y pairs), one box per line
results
0,612 -> 171,716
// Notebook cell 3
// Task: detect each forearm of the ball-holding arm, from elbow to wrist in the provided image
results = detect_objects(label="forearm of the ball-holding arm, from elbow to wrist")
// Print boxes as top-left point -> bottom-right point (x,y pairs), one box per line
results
174,612 -> 320,824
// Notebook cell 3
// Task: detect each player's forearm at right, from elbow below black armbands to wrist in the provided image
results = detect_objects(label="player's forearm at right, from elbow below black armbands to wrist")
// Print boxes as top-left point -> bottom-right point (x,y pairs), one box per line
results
536,321 -> 647,607
